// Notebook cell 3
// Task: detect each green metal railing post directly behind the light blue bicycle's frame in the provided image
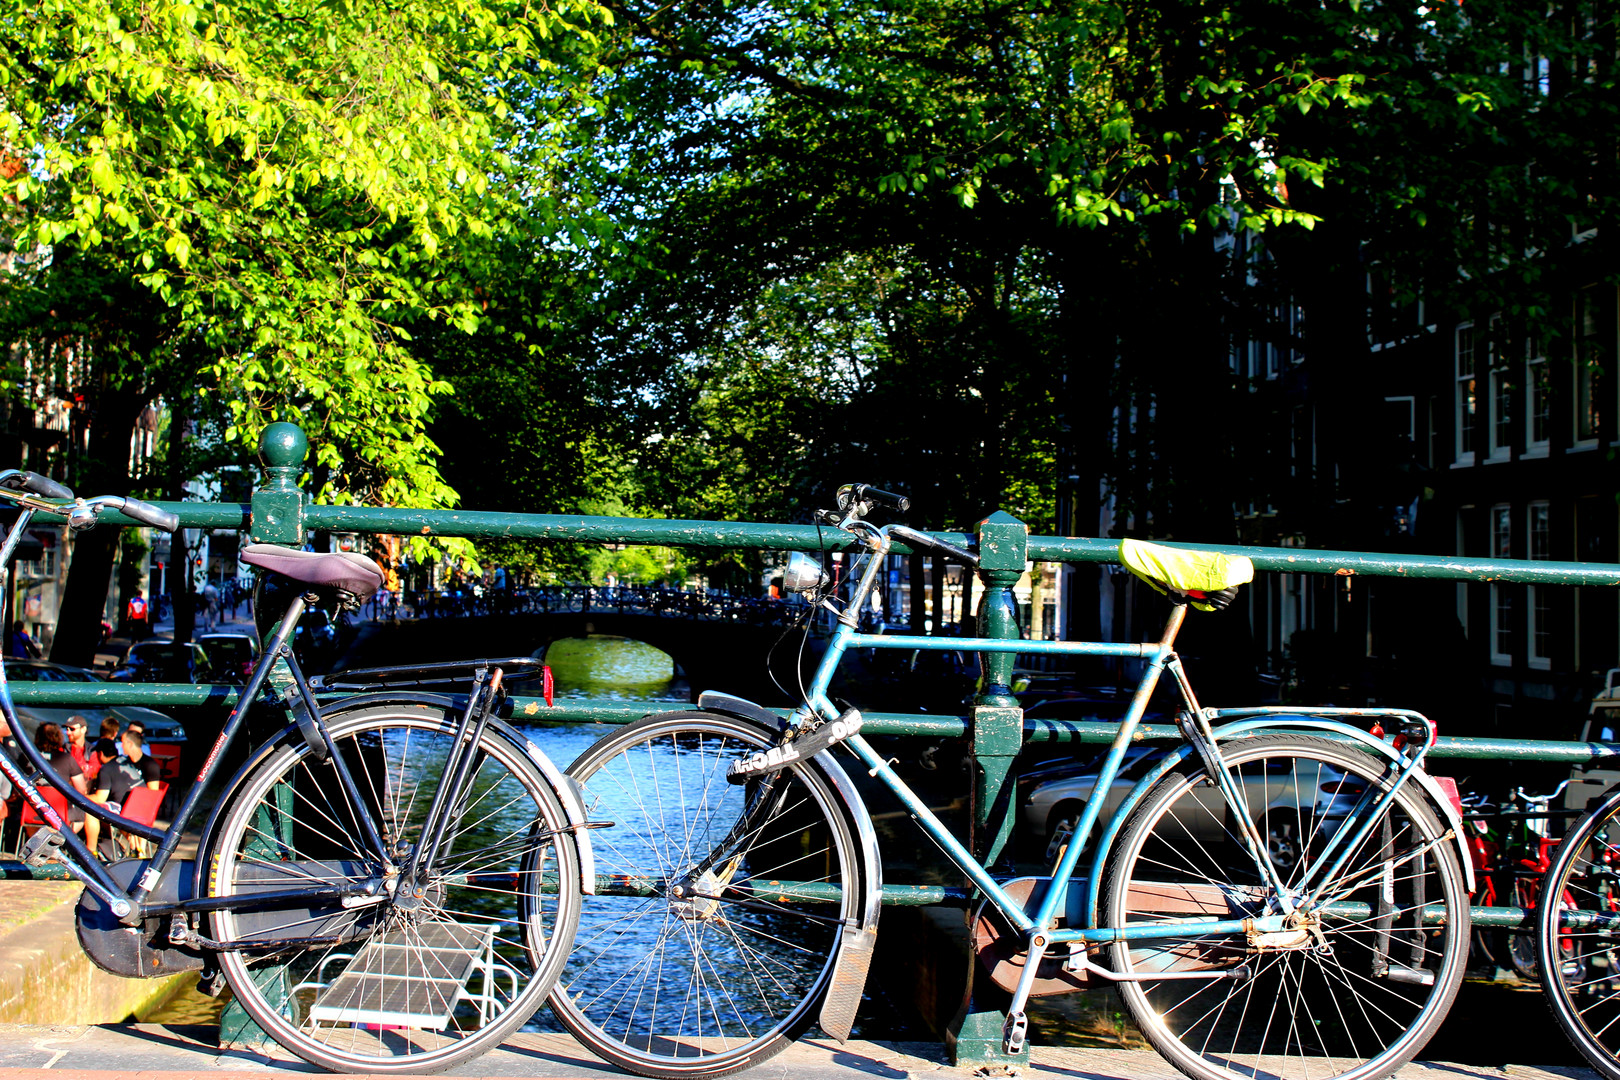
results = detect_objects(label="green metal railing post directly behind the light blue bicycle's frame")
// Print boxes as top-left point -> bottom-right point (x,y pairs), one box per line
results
946,510 -> 1029,1065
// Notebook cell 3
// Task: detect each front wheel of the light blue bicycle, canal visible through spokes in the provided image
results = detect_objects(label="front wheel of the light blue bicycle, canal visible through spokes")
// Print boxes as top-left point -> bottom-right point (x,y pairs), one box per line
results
551,711 -> 860,1078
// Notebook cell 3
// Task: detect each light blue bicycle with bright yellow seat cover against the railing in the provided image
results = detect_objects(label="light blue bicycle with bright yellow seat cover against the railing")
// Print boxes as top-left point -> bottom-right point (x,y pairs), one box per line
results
551,486 -> 1473,1080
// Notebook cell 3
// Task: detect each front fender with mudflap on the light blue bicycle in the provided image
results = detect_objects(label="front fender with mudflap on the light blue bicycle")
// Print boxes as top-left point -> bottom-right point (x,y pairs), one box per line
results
698,691 -> 883,1043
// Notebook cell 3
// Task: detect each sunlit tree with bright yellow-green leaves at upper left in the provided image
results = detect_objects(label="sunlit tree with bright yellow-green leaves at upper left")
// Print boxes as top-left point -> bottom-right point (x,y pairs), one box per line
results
0,0 -> 606,659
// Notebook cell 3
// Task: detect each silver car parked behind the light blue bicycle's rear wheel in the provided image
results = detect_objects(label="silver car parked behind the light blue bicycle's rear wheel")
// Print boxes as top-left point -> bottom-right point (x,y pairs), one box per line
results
1019,746 -> 1362,873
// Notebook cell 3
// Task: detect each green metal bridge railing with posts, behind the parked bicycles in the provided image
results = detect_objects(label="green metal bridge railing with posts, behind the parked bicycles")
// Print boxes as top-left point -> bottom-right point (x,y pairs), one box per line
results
9,423 -> 1620,1064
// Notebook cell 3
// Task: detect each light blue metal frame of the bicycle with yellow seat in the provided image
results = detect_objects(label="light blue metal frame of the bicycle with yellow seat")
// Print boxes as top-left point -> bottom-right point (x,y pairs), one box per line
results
792,526 -> 1466,958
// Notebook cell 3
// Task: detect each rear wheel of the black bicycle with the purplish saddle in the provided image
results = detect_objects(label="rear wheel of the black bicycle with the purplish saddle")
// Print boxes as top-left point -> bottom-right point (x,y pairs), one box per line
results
207,703 -> 580,1074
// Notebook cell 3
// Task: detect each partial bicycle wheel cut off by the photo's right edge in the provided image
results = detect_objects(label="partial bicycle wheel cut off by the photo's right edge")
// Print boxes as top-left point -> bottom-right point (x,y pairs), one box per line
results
1536,787 -> 1620,1080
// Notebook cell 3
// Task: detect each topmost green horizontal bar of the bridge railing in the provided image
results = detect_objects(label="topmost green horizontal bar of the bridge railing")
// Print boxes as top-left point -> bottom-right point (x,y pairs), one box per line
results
119,502 -> 1620,588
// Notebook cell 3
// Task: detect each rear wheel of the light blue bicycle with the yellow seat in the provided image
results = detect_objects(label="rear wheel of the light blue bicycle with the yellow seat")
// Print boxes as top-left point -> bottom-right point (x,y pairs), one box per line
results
1102,735 -> 1469,1080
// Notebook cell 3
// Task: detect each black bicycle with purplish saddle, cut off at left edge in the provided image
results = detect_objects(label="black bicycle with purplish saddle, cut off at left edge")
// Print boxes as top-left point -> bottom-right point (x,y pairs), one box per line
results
0,471 -> 595,1072
